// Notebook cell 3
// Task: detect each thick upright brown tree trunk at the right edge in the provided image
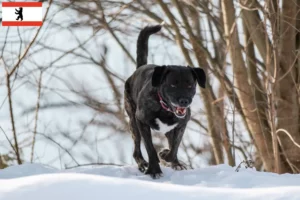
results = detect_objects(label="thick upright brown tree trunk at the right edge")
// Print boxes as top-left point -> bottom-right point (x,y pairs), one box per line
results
277,0 -> 300,173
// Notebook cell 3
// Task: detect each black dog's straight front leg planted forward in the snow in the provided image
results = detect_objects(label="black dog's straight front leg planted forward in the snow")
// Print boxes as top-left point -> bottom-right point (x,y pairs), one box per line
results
136,119 -> 162,178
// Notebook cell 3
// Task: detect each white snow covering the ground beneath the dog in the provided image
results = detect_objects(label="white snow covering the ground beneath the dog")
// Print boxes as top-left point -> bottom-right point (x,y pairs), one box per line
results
0,164 -> 300,200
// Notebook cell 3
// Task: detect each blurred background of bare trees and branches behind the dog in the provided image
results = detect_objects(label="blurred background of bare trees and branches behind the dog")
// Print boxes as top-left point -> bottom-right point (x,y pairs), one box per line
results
0,0 -> 300,173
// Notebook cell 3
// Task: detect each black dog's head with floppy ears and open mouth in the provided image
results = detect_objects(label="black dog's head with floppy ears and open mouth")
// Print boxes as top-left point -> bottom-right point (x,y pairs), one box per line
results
152,66 -> 206,118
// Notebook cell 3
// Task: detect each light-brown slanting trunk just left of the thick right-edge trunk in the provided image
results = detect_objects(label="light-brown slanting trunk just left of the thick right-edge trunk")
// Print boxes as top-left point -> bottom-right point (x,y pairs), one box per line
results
221,0 -> 274,171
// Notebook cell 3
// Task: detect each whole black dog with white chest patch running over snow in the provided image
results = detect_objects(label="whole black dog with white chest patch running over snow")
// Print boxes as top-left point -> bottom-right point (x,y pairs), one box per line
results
125,25 -> 206,178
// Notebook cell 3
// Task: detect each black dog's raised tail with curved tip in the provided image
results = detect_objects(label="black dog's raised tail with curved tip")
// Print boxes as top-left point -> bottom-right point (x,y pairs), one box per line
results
136,22 -> 164,68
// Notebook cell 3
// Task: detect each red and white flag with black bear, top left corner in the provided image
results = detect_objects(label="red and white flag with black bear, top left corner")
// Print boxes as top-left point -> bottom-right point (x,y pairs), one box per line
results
2,2 -> 43,26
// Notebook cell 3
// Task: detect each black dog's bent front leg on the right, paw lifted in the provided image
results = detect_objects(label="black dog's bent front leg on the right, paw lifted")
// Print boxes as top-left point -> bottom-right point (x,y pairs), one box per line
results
159,125 -> 186,170
